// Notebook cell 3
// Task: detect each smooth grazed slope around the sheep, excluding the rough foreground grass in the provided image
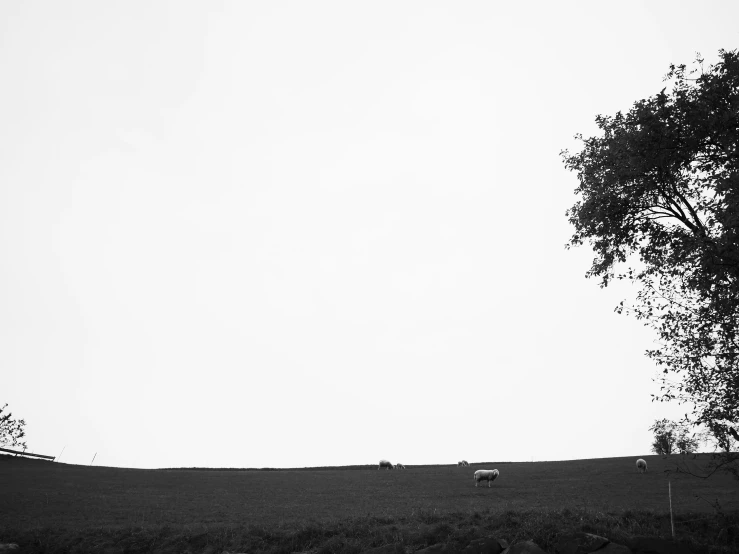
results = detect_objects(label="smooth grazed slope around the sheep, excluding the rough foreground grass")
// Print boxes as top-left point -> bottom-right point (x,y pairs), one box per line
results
0,455 -> 739,530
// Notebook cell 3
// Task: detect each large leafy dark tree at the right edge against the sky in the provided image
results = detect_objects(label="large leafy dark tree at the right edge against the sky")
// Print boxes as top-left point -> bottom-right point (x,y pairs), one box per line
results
562,50 -> 739,439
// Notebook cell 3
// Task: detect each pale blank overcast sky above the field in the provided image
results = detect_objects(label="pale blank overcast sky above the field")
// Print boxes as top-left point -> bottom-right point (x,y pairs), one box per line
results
0,0 -> 739,468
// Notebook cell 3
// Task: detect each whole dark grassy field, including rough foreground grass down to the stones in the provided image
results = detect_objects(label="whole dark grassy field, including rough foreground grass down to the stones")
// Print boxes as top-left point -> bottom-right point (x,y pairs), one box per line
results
0,456 -> 739,553
